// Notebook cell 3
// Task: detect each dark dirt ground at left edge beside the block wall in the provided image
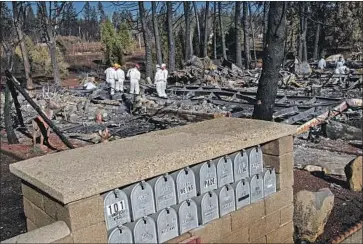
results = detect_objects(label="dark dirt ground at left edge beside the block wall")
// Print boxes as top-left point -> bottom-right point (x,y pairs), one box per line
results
0,153 -> 26,241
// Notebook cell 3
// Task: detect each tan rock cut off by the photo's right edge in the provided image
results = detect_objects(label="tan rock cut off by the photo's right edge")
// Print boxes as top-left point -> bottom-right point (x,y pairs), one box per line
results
344,156 -> 363,191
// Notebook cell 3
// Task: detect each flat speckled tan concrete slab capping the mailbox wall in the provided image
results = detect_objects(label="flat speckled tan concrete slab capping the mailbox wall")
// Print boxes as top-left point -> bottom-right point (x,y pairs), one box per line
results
10,118 -> 297,204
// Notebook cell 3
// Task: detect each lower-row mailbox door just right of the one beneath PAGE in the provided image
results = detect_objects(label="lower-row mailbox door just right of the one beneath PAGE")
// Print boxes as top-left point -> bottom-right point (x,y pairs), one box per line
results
216,184 -> 236,217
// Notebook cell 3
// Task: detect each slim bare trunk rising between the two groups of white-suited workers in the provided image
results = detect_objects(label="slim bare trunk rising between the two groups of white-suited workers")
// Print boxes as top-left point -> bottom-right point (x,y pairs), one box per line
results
138,2 -> 153,78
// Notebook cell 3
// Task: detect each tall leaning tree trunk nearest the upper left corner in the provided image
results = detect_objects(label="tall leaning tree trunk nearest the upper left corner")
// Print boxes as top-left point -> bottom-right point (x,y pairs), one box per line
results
12,1 -> 33,90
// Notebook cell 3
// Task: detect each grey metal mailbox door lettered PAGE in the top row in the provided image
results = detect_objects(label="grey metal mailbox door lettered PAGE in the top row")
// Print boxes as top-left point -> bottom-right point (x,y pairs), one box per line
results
192,161 -> 218,195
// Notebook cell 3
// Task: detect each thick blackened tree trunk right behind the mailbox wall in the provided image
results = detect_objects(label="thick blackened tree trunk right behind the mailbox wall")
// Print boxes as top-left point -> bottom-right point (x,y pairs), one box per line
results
252,2 -> 286,121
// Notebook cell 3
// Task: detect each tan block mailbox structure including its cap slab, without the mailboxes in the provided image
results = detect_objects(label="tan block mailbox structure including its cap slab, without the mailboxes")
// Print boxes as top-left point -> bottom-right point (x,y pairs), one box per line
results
10,118 -> 296,243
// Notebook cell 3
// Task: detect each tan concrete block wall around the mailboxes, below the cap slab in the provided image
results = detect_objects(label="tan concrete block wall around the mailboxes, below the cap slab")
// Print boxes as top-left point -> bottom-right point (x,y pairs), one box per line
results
16,136 -> 294,243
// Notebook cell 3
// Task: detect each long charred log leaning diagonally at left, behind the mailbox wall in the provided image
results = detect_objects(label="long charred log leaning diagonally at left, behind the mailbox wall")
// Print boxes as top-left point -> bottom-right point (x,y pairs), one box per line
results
5,70 -> 74,149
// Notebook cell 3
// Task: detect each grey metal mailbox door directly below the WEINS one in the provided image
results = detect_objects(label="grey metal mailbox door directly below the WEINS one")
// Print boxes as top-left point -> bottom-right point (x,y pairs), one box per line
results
172,199 -> 199,235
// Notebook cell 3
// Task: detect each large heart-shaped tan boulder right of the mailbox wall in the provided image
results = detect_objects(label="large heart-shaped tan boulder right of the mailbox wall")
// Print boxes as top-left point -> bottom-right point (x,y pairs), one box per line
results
294,188 -> 334,242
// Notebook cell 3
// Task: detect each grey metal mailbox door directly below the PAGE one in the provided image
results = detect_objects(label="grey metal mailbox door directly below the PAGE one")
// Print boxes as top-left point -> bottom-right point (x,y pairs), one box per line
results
194,191 -> 219,225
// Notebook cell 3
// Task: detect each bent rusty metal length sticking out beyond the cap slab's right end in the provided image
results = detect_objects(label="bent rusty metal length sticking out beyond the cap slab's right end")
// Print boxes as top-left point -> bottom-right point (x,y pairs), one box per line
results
297,99 -> 363,134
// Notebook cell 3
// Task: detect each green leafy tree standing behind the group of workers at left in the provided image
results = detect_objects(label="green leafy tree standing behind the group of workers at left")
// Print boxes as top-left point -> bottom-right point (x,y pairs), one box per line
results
101,20 -> 133,65
